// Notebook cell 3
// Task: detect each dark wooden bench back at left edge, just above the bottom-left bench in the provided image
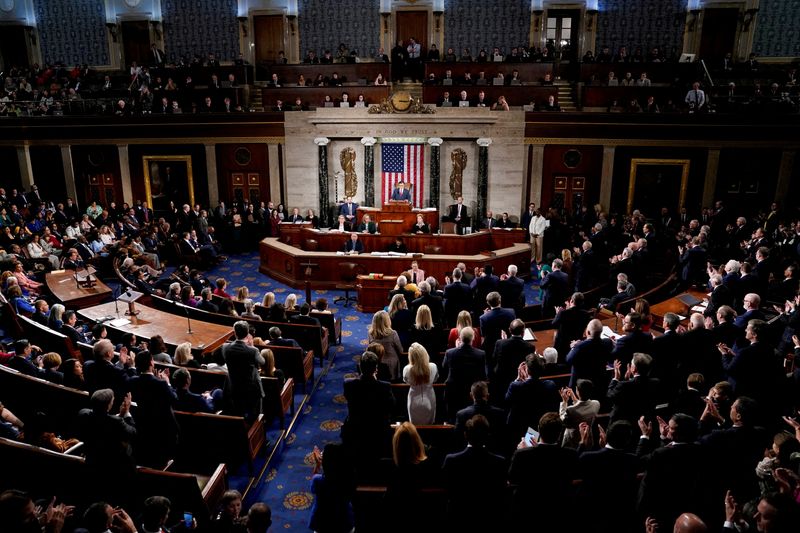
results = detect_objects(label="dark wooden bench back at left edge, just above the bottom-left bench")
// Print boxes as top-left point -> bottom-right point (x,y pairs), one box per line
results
0,365 -> 89,438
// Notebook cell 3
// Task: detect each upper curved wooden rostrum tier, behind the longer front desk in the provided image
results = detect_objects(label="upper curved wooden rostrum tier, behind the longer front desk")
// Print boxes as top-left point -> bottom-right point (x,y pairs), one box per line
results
292,228 -> 528,256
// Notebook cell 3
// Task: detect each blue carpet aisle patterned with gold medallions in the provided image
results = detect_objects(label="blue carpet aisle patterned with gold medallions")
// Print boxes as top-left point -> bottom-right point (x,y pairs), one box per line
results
200,253 -> 539,531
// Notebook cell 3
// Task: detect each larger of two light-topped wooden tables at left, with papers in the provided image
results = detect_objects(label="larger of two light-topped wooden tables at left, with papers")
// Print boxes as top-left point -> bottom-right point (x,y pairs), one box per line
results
78,302 -> 233,353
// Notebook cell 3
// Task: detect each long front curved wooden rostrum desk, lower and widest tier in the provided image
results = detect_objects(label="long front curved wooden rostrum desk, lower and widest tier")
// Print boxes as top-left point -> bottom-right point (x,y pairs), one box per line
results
258,237 -> 531,290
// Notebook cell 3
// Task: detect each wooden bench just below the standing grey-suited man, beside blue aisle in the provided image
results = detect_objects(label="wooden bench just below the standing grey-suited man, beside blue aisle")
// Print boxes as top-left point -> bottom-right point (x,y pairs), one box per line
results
175,411 -> 267,470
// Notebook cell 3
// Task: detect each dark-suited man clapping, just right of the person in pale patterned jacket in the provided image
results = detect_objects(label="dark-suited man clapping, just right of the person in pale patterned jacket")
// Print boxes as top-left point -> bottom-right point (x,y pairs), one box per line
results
608,352 -> 660,423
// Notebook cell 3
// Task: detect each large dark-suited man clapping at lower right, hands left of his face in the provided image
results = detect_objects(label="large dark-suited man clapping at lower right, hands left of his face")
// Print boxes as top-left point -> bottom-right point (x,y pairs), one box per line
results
636,413 -> 708,524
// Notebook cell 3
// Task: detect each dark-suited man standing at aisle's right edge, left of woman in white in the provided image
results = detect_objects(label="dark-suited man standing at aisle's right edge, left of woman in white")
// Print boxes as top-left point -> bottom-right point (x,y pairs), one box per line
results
342,352 -> 394,460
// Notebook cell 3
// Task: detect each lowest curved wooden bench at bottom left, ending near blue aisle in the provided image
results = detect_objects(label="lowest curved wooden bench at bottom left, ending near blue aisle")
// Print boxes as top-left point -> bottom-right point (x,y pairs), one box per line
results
0,438 -> 227,526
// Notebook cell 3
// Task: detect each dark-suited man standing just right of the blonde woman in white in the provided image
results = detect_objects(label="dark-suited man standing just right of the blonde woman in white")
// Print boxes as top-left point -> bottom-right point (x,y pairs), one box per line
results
441,327 -> 486,421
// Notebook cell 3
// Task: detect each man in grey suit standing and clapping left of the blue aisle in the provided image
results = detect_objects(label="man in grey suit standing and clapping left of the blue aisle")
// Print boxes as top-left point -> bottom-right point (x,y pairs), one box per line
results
222,320 -> 264,420
